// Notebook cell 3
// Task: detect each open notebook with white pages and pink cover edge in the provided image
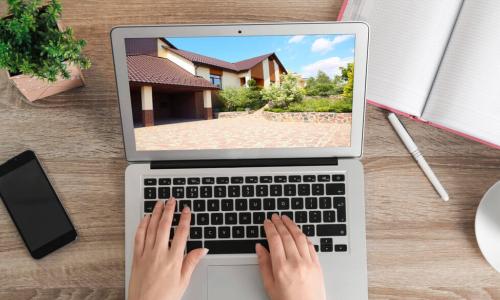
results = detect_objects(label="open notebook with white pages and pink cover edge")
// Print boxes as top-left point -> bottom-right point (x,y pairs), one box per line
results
338,0 -> 500,149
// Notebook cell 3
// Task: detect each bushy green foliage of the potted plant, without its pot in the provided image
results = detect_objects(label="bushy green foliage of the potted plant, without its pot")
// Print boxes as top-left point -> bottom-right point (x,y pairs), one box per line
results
0,0 -> 90,82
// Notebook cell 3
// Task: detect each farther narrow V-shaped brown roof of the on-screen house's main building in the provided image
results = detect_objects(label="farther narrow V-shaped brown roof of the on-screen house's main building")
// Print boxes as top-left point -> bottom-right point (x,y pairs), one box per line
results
167,48 -> 273,72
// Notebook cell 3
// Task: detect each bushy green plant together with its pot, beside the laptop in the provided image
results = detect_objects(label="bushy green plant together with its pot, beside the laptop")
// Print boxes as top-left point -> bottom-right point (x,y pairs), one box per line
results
0,0 -> 90,101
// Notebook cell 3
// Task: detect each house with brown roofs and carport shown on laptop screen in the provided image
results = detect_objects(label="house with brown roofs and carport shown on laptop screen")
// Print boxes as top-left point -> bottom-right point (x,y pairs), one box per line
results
125,38 -> 287,126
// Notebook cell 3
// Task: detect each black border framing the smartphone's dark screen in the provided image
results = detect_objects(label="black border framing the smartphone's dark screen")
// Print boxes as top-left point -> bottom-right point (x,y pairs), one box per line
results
0,150 -> 77,259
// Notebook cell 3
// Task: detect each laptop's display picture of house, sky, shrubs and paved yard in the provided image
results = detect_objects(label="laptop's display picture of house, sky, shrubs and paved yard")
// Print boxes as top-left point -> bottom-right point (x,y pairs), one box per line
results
125,34 -> 355,151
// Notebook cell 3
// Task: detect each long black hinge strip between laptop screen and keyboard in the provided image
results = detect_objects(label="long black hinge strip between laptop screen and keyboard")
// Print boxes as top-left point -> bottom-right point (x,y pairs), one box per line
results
151,157 -> 338,169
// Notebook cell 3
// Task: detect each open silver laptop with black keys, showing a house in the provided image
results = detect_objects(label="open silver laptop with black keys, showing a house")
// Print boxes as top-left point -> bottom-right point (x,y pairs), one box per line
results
111,23 -> 368,300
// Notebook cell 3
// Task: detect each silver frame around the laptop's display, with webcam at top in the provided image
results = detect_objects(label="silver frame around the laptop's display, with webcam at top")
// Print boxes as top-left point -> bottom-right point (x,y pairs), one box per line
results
111,22 -> 369,162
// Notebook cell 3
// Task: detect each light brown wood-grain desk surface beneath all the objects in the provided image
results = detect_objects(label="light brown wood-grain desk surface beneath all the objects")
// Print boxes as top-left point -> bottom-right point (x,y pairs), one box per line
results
0,0 -> 500,299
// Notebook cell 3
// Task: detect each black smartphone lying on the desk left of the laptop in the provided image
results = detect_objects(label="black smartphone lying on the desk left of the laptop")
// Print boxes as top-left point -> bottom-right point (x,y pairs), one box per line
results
0,150 -> 77,259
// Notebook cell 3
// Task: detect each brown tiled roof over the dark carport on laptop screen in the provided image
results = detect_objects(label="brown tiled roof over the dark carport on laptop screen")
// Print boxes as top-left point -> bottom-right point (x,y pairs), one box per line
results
127,55 -> 219,89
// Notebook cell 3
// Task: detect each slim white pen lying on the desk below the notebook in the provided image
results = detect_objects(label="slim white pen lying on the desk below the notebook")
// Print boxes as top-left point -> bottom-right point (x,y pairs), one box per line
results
387,113 -> 450,201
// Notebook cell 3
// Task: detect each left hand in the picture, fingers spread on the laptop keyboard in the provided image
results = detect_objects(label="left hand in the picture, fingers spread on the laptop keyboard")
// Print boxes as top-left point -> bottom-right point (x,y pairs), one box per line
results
128,198 -> 208,300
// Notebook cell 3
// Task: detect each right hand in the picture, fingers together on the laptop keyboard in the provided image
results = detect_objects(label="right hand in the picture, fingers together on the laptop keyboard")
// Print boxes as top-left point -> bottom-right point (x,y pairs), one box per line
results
255,214 -> 326,300
